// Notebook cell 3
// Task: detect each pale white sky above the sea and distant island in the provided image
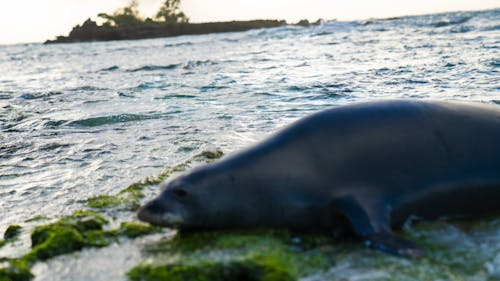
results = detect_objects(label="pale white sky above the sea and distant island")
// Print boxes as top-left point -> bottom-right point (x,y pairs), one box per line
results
0,0 -> 500,44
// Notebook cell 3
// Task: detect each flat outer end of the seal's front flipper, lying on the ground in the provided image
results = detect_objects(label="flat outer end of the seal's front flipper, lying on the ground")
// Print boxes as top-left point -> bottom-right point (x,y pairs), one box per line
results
364,233 -> 424,258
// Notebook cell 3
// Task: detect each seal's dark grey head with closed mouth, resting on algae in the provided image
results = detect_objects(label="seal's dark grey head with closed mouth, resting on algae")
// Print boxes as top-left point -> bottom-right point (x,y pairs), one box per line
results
138,166 -> 252,228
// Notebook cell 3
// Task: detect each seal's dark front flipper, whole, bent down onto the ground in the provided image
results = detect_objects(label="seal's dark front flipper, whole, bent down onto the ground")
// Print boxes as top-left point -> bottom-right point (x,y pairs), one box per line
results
331,197 -> 423,258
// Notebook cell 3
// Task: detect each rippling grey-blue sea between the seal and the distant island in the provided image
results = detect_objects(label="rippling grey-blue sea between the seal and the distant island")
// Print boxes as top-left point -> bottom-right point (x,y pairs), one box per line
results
0,7 -> 500,280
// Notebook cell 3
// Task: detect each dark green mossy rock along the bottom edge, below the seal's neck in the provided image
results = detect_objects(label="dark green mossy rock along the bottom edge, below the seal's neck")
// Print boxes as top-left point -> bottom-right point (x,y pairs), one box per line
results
128,259 -> 296,281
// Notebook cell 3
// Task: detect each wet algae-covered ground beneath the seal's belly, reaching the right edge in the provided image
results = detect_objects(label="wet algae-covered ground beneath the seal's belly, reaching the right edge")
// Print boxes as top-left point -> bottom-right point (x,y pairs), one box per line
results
128,215 -> 500,281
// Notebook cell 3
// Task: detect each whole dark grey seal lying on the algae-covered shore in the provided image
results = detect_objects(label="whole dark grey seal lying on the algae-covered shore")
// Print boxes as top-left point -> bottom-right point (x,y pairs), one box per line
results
138,100 -> 500,257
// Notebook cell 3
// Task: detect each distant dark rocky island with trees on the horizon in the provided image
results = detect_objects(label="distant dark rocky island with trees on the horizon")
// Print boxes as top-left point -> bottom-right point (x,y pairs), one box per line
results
45,0 -> 320,44
